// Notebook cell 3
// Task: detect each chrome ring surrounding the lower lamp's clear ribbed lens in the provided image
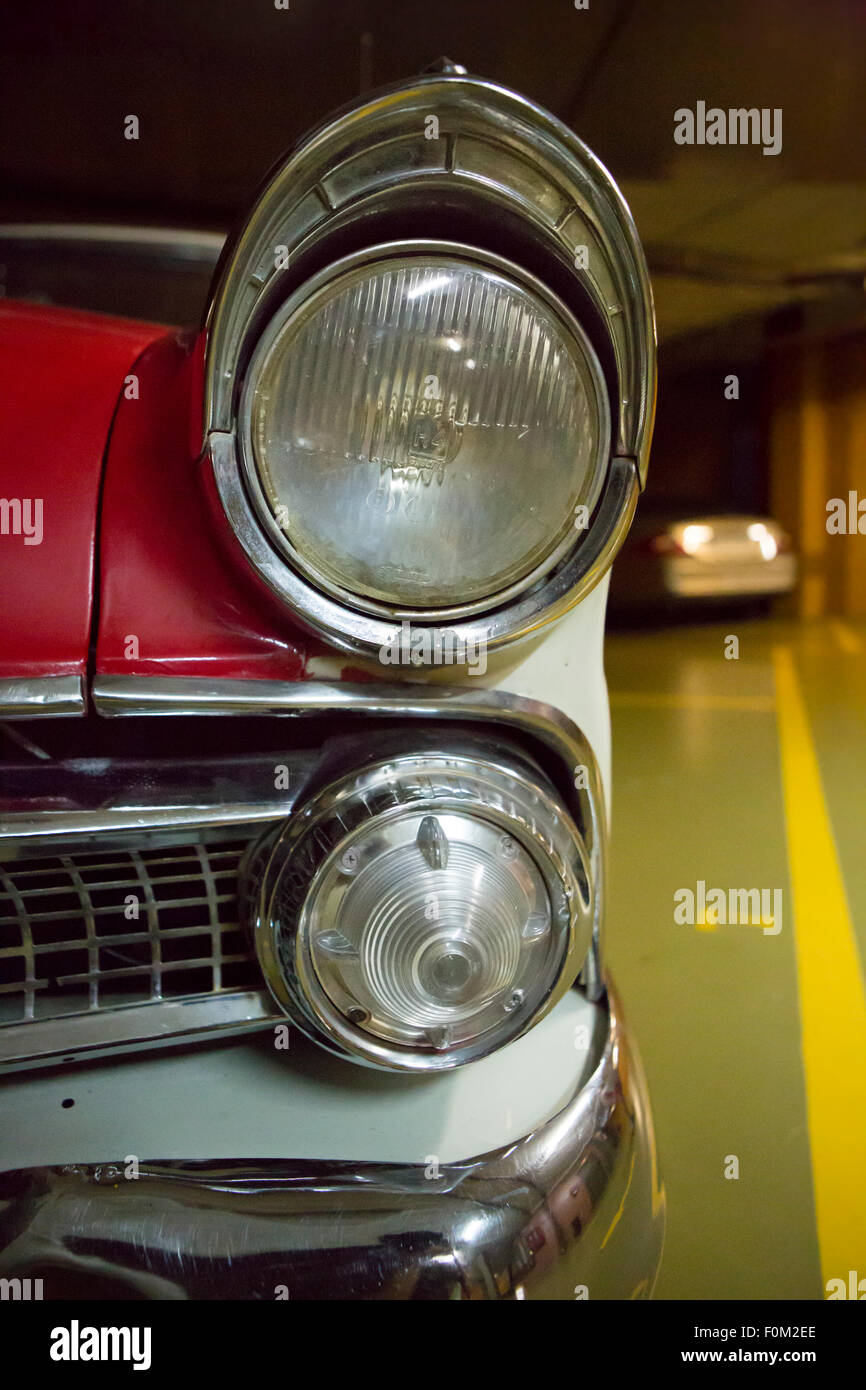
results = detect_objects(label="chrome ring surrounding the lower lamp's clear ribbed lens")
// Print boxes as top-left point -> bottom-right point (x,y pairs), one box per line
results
254,752 -> 598,1073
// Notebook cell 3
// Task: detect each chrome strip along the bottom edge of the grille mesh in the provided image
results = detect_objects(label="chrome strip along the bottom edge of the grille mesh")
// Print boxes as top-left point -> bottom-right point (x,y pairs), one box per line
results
0,990 -> 273,1072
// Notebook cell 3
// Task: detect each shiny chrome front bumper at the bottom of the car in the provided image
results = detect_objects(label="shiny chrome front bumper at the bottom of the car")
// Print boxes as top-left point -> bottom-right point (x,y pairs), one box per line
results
0,1006 -> 664,1300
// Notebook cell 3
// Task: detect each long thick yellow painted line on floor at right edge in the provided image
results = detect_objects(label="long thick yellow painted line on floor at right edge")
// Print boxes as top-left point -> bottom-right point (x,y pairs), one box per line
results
773,646 -> 866,1286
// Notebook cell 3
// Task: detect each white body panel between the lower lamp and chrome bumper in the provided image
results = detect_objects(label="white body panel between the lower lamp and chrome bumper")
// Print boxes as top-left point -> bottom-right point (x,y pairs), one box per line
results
0,991 -> 606,1172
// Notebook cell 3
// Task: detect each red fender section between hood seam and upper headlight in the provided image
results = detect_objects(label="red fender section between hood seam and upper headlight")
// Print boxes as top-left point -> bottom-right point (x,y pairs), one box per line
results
96,321 -> 312,681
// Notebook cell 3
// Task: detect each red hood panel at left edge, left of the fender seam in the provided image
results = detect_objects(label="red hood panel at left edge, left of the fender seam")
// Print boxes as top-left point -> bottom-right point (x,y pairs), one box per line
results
0,302 -> 165,678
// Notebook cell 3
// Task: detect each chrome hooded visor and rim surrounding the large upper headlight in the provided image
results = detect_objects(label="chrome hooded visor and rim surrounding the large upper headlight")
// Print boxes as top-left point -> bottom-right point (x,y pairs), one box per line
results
203,75 -> 655,659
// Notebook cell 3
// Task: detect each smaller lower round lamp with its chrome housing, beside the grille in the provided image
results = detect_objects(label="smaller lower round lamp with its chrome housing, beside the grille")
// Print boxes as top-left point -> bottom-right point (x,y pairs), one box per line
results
256,755 -> 592,1070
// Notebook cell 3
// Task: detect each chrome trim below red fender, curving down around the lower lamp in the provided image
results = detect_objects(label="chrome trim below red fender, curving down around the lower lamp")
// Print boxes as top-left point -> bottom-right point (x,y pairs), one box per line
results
92,676 -> 606,998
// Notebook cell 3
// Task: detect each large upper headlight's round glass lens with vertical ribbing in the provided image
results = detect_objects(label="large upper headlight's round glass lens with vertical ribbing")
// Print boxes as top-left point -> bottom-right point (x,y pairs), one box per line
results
246,254 -> 607,613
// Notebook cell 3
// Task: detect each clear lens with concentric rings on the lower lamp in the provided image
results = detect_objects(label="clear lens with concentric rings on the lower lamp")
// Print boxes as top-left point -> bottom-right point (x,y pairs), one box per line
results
307,812 -> 553,1047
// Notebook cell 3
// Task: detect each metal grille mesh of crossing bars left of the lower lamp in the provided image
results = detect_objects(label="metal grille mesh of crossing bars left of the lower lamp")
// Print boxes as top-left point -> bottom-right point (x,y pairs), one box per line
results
0,842 -> 261,1024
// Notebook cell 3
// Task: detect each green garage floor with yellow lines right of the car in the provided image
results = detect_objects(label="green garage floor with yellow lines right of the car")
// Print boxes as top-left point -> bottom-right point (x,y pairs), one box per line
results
606,620 -> 866,1298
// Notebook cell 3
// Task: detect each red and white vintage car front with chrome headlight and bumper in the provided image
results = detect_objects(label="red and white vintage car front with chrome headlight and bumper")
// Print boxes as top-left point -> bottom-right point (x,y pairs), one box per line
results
0,63 -> 664,1300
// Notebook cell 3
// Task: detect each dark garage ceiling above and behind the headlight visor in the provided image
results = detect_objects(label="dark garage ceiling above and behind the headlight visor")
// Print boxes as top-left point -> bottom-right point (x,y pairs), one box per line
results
0,0 -> 866,339
